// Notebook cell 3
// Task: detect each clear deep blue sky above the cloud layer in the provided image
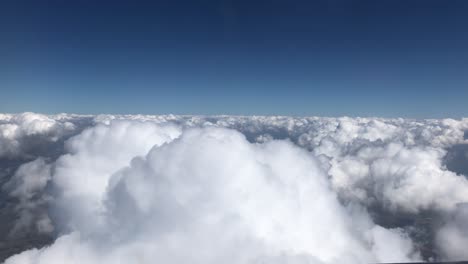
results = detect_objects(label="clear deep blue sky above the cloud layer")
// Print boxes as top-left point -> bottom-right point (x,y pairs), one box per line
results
0,0 -> 468,118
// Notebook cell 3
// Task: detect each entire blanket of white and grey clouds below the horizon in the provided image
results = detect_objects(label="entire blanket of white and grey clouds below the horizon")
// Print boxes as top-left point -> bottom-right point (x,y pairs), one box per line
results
0,113 -> 468,263
